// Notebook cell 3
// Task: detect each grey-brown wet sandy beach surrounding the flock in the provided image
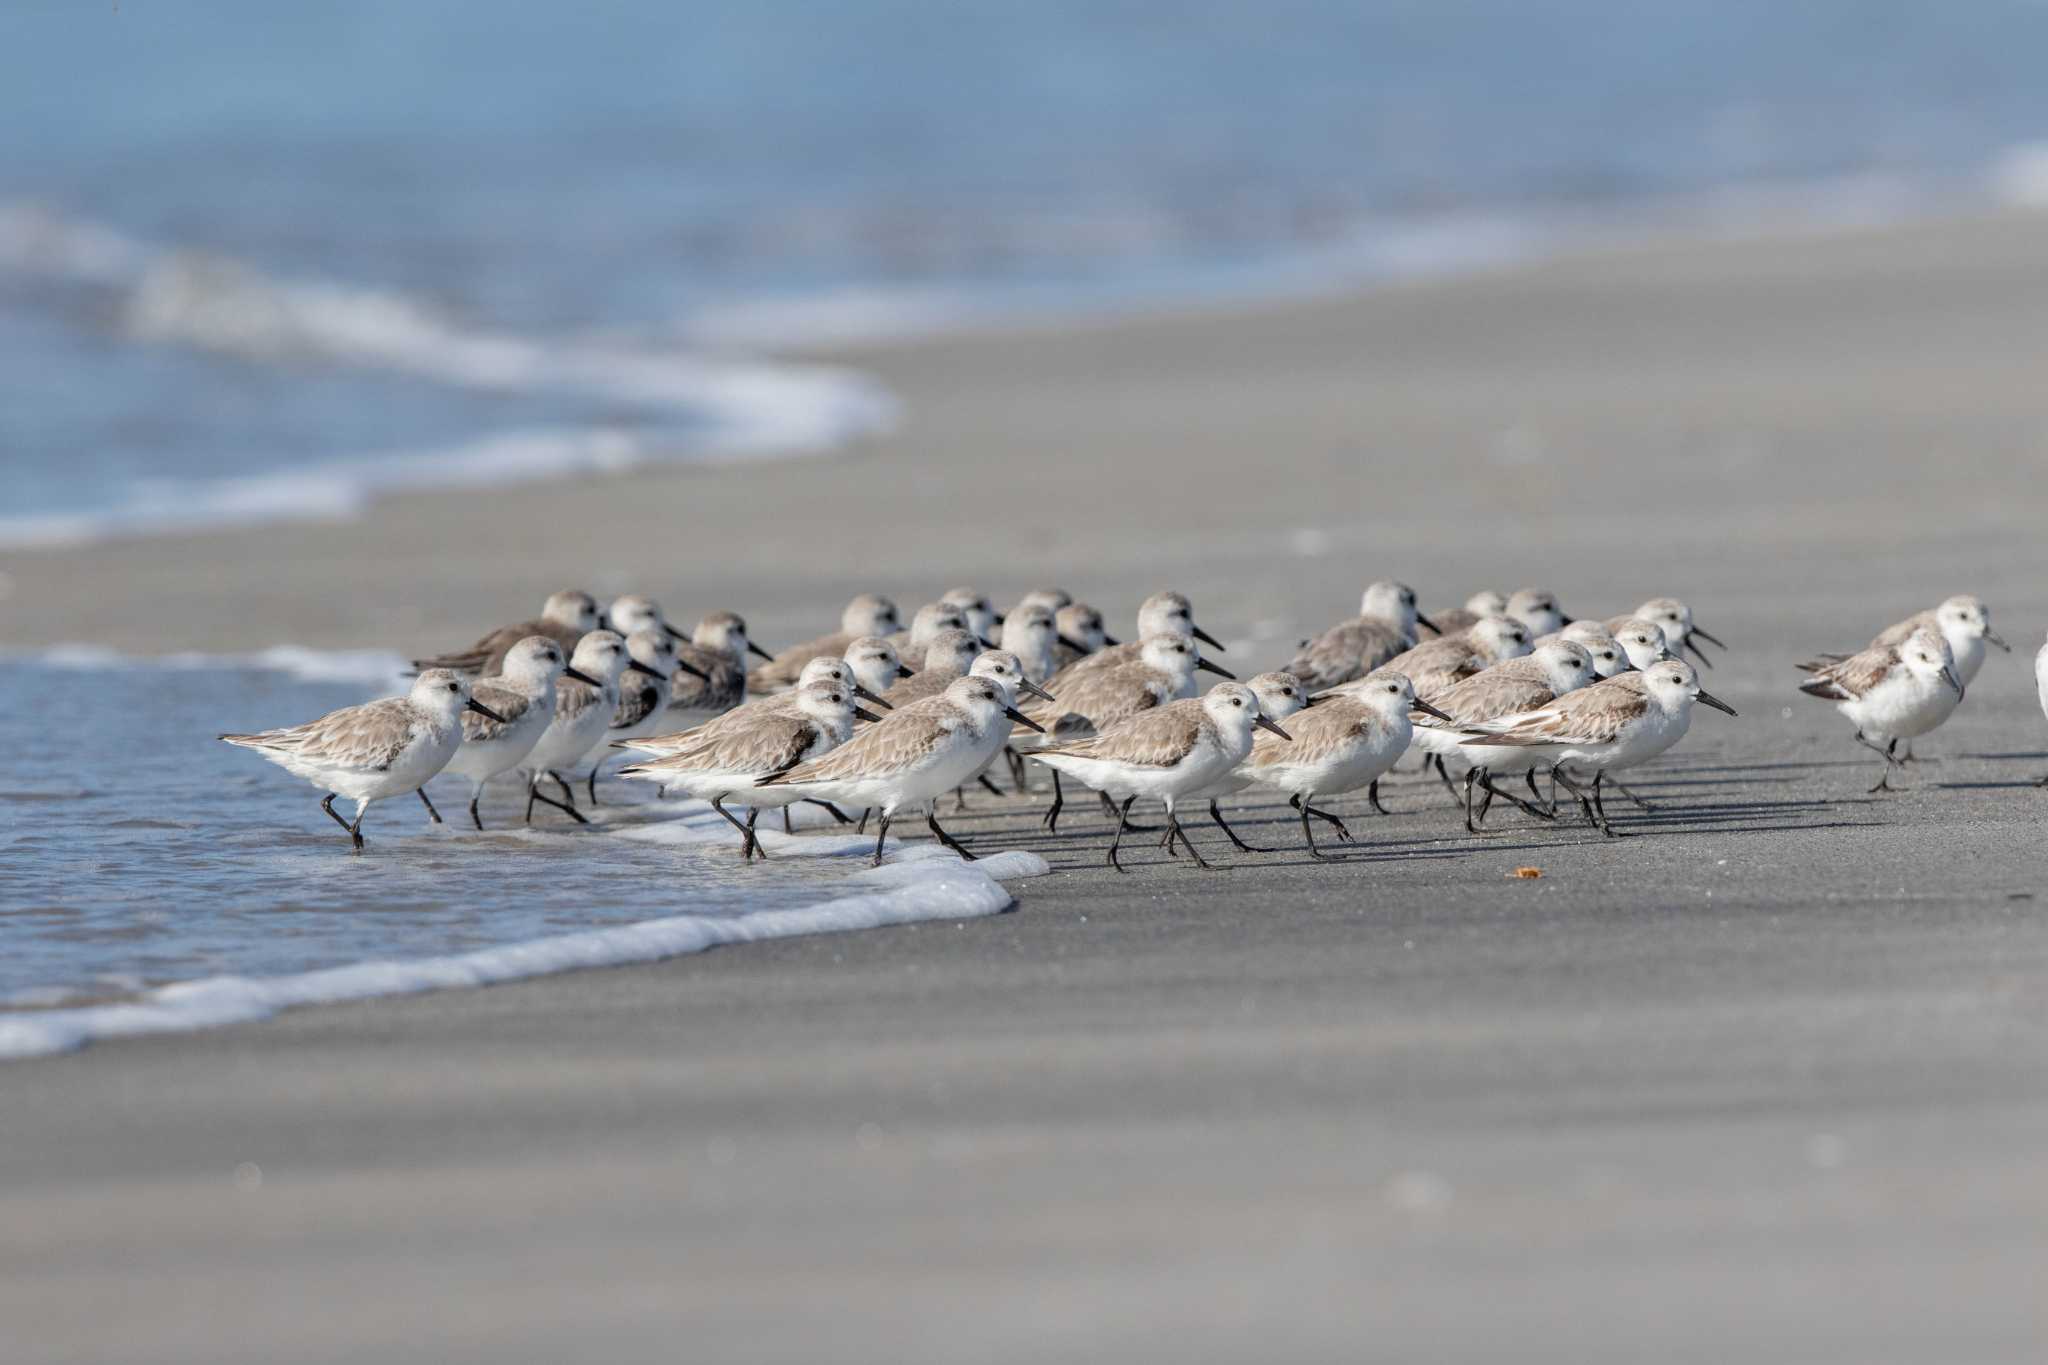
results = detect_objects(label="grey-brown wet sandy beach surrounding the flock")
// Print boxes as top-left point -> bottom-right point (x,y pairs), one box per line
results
0,215 -> 2048,1363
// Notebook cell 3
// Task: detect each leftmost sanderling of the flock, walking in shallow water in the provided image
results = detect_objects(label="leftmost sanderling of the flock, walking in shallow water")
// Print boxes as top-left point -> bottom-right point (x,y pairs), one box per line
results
221,667 -> 503,853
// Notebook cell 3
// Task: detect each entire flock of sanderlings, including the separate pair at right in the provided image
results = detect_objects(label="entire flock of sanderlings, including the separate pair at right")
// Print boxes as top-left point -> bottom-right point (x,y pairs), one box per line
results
221,583 -> 2048,870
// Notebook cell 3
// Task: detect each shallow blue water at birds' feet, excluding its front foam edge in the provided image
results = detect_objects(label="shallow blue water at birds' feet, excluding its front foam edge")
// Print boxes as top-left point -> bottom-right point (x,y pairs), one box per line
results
0,657 -> 921,1009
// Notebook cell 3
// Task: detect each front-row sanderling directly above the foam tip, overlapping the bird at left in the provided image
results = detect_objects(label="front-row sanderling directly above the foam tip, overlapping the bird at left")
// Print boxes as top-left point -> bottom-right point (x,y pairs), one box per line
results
756,677 -> 1038,864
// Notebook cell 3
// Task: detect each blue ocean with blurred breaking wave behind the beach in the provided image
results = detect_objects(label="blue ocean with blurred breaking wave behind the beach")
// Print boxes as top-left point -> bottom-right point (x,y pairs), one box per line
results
0,0 -> 2048,544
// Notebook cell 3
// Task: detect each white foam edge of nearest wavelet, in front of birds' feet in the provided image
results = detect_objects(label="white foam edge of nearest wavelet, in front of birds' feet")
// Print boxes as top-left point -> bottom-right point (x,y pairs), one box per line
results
0,834 -> 1049,1060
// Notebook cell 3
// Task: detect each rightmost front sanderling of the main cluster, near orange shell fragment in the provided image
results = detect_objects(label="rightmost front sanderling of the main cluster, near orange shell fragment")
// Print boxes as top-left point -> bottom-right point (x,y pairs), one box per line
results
1464,659 -> 1735,839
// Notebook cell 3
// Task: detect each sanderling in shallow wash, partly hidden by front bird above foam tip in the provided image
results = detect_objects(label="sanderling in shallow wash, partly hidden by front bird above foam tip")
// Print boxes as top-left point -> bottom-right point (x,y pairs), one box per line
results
618,683 -> 874,862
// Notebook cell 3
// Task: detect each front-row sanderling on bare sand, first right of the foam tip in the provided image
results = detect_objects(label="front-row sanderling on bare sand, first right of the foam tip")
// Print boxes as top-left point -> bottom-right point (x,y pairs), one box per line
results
1030,684 -> 1286,872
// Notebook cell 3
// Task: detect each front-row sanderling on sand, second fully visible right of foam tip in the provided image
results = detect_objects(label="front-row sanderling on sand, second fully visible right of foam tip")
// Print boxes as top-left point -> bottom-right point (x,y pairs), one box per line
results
1237,669 -> 1450,857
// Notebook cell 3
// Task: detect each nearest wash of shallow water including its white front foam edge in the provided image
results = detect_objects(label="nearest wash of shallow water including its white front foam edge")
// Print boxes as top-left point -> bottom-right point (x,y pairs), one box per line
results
0,651 -> 1044,1058
